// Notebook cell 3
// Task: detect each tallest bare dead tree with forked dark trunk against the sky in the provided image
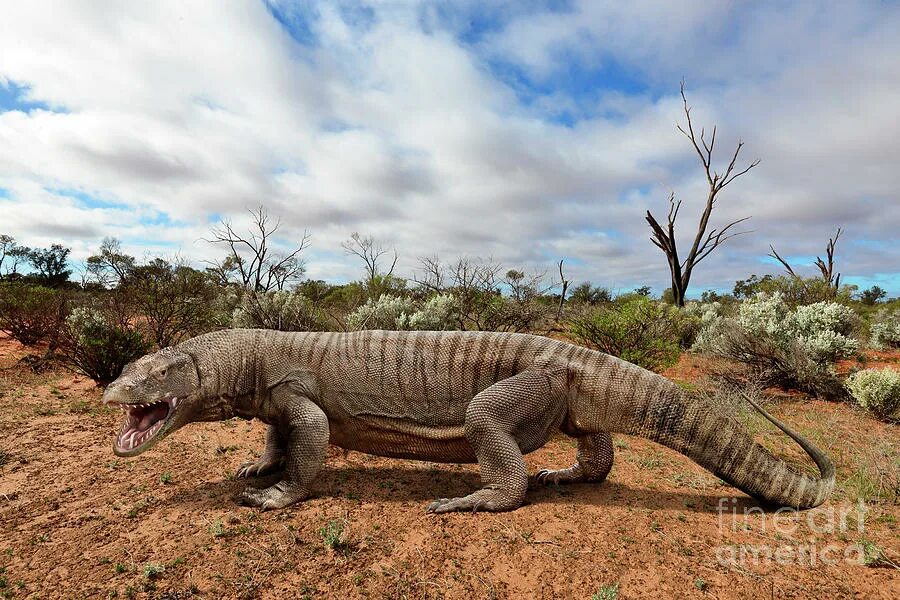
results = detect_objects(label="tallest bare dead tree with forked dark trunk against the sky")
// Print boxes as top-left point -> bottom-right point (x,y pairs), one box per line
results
645,81 -> 759,306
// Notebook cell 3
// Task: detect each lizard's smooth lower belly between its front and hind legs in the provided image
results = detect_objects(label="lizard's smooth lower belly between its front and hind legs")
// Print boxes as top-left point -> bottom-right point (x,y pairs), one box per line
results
330,415 -> 477,463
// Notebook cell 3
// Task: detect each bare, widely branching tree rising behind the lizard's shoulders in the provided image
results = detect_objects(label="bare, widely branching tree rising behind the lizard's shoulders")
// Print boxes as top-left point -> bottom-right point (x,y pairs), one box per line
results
206,206 -> 309,292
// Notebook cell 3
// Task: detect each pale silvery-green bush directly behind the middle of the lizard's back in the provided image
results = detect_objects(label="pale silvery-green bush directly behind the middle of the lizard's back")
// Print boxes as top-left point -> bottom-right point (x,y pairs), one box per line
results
347,294 -> 458,331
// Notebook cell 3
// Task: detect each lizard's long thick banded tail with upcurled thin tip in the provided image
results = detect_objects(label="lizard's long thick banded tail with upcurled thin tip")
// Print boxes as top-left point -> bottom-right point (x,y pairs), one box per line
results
576,361 -> 834,509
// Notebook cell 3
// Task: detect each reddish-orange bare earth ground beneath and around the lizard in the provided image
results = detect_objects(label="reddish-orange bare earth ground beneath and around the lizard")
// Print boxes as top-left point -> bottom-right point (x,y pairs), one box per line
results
0,338 -> 900,599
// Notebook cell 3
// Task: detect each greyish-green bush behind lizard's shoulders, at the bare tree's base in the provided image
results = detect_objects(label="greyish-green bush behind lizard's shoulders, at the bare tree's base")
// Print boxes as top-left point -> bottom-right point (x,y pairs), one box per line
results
231,290 -> 328,331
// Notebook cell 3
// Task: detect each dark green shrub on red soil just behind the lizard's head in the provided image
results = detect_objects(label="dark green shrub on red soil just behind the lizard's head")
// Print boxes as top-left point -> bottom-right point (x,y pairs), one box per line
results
63,307 -> 149,386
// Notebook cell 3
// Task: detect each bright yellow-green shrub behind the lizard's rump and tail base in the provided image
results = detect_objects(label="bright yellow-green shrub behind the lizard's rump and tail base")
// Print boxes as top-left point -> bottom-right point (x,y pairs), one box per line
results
569,295 -> 693,370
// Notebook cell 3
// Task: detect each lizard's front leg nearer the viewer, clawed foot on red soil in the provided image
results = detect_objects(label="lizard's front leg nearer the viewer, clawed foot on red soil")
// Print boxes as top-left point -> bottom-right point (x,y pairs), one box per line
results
240,394 -> 328,510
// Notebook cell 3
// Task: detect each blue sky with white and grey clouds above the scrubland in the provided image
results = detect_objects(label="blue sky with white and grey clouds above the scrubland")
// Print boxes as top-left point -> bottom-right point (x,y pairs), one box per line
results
0,0 -> 900,295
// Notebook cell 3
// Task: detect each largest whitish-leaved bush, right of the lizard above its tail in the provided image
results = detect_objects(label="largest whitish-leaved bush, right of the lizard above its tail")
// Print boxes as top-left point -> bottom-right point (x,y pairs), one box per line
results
694,292 -> 859,399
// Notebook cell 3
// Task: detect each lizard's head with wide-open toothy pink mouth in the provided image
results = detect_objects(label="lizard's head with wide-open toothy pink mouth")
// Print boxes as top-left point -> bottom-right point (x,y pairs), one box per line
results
103,348 -> 200,456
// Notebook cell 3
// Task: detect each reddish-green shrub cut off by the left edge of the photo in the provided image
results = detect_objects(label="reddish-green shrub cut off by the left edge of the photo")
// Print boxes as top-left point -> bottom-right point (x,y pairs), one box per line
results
0,283 -> 66,346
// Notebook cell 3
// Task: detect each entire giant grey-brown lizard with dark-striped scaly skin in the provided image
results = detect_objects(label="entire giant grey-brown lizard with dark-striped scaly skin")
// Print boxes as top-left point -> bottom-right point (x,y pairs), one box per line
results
104,329 -> 834,513
